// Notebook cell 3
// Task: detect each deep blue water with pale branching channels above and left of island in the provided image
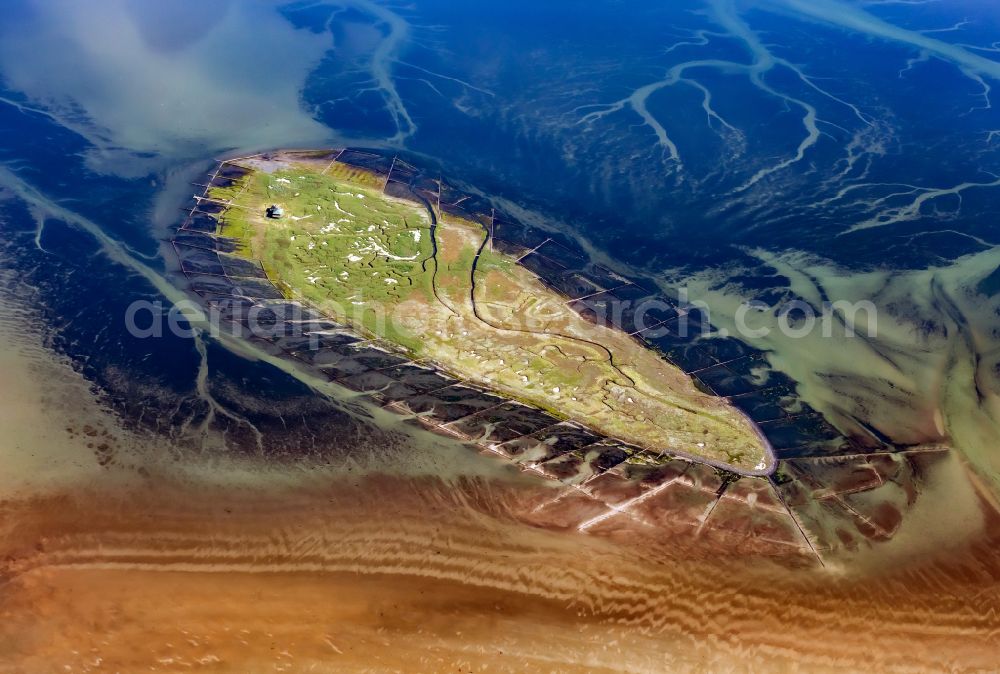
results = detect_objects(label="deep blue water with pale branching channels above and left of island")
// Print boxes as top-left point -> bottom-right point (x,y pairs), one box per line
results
0,0 -> 1000,456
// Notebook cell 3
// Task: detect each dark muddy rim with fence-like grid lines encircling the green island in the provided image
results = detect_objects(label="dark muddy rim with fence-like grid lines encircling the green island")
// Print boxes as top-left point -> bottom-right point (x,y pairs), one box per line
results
173,149 -> 776,476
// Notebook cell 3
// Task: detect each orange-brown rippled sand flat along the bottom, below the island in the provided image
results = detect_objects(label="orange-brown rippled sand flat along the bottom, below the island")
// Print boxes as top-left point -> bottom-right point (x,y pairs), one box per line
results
0,478 -> 1000,671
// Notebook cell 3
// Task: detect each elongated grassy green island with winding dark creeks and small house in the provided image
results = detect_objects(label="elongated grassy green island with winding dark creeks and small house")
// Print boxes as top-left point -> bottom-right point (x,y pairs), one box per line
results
180,151 -> 771,473
